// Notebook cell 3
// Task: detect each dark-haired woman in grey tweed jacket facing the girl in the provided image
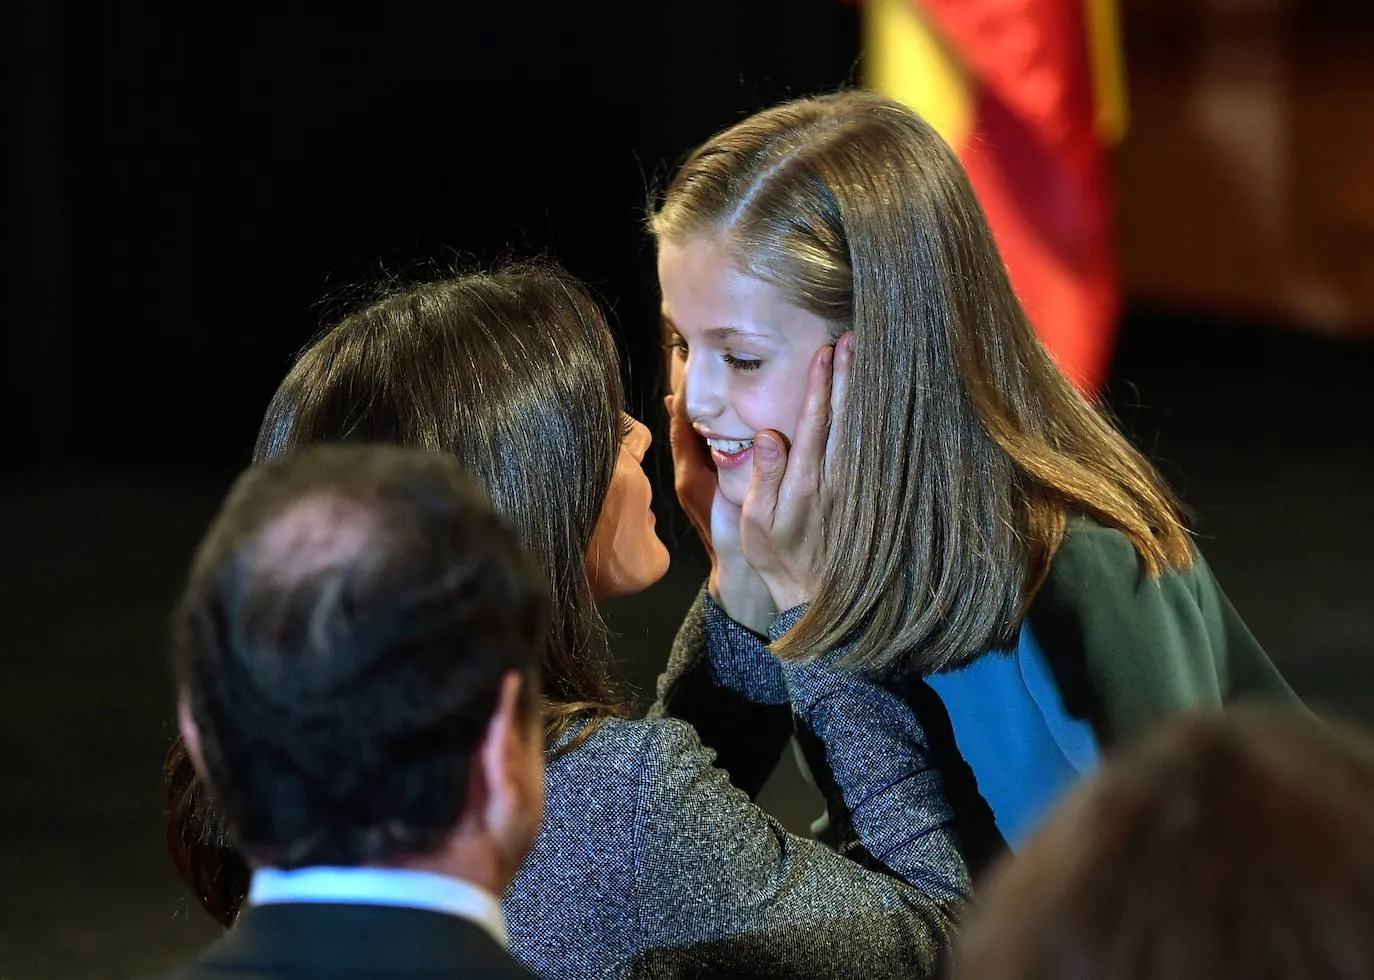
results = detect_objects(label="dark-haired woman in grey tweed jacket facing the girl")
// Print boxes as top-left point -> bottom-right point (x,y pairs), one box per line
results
168,268 -> 967,977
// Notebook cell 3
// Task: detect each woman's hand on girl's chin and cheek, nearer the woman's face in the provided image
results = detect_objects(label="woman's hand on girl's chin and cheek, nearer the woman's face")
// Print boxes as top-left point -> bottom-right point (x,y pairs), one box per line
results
664,393 -> 778,634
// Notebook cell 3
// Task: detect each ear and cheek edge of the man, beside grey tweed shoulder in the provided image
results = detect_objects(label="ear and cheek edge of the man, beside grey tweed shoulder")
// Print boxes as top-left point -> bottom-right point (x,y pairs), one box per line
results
470,671 -> 544,866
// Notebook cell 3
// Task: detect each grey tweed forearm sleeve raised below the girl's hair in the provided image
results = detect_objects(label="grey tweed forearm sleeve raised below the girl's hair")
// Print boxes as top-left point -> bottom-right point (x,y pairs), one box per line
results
768,606 -> 971,900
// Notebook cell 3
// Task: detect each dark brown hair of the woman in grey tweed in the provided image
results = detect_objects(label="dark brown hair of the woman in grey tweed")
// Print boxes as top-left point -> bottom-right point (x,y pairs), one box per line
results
164,264 -> 627,925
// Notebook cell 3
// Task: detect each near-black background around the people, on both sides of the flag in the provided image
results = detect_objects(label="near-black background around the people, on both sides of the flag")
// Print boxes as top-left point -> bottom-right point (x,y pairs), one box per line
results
0,0 -> 1374,977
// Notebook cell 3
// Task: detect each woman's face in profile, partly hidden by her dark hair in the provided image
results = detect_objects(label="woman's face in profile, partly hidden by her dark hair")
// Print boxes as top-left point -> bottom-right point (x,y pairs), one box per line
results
587,415 -> 668,599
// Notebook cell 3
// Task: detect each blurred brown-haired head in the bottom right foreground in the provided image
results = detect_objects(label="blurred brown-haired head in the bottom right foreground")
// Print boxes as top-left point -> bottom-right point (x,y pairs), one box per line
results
956,708 -> 1374,980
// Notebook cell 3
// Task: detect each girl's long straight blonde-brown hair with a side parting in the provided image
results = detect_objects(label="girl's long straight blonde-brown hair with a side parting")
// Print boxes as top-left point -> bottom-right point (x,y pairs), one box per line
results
650,91 -> 1193,672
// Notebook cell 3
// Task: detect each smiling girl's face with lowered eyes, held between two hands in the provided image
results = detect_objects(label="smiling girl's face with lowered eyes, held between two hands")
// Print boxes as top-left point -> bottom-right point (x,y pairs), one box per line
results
658,238 -> 834,504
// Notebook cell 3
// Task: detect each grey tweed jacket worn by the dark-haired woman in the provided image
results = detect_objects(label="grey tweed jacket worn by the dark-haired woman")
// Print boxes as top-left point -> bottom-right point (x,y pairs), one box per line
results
504,595 -> 969,980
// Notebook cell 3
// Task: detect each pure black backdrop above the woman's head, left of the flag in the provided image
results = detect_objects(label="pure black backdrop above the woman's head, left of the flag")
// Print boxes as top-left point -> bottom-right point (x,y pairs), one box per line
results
3,0 -> 859,470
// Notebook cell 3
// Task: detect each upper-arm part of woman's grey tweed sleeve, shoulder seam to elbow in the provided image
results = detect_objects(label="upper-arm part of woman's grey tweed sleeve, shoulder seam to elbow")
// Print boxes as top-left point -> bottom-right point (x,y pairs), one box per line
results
632,724 -> 958,980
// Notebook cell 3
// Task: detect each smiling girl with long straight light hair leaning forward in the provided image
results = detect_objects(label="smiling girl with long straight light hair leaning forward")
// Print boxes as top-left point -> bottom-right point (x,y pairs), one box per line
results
650,91 -> 1293,867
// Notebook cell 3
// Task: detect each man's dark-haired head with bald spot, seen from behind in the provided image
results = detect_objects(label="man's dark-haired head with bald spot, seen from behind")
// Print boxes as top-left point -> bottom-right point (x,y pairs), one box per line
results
173,445 -> 548,887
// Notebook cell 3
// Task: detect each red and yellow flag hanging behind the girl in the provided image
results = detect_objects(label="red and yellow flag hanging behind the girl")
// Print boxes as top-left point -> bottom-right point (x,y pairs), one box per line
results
863,0 -> 1125,394
